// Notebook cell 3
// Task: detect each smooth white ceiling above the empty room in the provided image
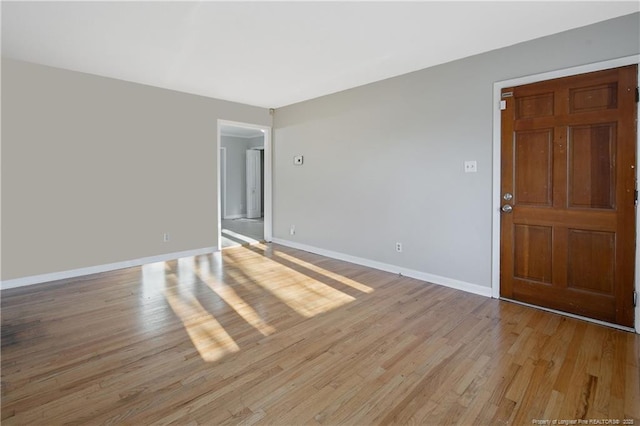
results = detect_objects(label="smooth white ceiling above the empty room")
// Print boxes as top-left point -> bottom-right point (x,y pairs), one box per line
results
2,1 -> 640,108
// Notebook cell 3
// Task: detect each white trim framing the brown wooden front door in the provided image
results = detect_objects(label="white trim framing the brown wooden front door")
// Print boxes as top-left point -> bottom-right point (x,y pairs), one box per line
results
491,55 -> 640,334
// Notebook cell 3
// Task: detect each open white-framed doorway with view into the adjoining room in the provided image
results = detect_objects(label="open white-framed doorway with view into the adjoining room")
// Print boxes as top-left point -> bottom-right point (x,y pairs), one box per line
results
218,120 -> 271,250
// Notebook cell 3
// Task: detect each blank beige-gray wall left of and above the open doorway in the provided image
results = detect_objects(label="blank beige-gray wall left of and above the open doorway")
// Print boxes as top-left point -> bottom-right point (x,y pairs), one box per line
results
2,58 -> 271,280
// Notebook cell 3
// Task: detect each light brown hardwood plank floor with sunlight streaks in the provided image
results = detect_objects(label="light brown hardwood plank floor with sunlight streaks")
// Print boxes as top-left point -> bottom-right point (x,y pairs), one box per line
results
1,245 -> 640,425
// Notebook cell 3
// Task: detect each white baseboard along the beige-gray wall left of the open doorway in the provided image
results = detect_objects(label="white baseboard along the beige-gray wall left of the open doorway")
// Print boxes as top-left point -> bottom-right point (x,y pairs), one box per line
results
0,247 -> 218,290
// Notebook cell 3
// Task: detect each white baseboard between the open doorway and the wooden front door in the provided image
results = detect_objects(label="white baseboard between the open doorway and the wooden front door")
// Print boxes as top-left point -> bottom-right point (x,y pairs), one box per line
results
273,238 -> 491,297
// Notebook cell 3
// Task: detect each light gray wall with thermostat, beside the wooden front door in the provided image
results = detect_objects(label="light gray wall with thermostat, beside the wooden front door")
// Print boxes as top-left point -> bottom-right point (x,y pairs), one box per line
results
273,14 -> 640,287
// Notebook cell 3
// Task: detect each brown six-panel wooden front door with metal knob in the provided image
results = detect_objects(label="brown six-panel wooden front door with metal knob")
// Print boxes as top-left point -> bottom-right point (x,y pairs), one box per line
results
500,65 -> 638,327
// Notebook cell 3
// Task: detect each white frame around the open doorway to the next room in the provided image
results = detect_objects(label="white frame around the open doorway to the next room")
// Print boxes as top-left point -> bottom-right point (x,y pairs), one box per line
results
216,119 -> 273,250
